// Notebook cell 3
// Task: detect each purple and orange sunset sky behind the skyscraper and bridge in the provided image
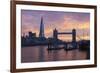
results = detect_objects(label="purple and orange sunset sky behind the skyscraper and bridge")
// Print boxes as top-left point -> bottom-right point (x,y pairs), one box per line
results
21,10 -> 90,40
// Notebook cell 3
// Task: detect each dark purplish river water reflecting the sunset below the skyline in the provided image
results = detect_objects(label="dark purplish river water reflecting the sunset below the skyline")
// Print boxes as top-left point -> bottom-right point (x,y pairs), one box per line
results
21,46 -> 87,63
